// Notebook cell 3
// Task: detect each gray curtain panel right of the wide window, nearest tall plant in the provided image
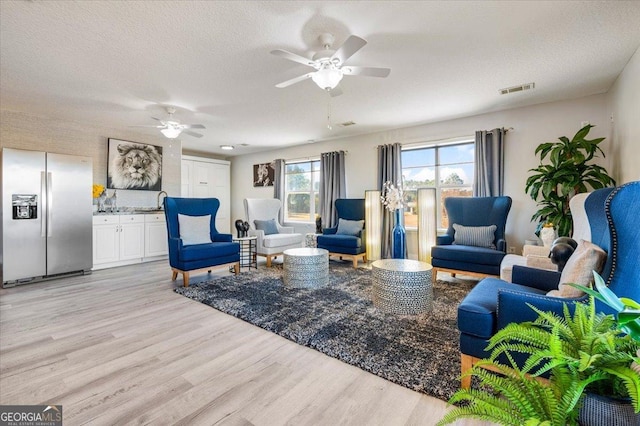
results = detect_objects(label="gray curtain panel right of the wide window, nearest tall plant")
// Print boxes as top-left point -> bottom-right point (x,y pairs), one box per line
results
473,129 -> 507,197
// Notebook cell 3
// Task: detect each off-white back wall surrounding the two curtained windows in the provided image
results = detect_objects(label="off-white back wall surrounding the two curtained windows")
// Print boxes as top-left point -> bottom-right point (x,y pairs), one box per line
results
231,94 -> 611,257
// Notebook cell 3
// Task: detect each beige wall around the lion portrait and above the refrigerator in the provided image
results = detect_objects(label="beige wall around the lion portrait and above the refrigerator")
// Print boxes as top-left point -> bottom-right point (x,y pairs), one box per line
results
0,110 -> 182,207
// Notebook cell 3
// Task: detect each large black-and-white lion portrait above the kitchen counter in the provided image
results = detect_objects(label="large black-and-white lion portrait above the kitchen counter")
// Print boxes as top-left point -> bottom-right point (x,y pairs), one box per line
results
107,139 -> 162,191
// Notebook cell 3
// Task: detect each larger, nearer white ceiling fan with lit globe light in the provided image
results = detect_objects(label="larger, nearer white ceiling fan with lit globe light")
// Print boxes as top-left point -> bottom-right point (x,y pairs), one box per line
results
271,33 -> 391,96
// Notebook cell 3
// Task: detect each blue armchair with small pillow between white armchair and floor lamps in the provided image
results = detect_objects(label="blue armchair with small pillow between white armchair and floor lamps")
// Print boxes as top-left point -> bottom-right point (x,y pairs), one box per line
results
317,198 -> 367,268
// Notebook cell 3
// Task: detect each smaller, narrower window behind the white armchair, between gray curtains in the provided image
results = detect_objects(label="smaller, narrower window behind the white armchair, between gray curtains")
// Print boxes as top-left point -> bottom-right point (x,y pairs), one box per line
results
284,160 -> 320,222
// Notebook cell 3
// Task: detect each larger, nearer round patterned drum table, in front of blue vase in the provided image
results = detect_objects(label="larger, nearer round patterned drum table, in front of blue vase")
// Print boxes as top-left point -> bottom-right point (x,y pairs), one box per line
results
371,259 -> 433,315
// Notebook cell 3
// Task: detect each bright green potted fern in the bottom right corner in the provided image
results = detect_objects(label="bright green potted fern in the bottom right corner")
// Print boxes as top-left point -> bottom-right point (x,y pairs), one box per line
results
489,297 -> 640,426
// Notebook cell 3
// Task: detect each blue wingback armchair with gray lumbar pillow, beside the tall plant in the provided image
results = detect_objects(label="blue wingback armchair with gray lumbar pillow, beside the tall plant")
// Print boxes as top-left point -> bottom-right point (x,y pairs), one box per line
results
431,197 -> 511,282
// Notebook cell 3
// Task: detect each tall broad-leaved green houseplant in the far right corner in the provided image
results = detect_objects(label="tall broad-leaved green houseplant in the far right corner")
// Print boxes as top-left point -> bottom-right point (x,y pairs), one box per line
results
525,124 -> 616,237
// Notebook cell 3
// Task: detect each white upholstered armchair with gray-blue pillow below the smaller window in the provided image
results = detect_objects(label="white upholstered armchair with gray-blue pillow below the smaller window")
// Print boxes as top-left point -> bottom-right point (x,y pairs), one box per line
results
244,198 -> 304,267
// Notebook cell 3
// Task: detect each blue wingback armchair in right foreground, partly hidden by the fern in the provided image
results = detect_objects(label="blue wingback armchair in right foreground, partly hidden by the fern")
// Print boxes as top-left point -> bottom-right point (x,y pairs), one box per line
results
458,181 -> 640,387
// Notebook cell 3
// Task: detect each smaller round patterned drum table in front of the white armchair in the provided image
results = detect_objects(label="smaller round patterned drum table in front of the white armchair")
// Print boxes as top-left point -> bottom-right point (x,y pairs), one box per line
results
282,247 -> 329,288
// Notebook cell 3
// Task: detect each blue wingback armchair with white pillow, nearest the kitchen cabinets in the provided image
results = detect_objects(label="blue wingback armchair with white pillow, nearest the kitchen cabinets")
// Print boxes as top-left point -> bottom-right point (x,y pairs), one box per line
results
164,197 -> 240,287
